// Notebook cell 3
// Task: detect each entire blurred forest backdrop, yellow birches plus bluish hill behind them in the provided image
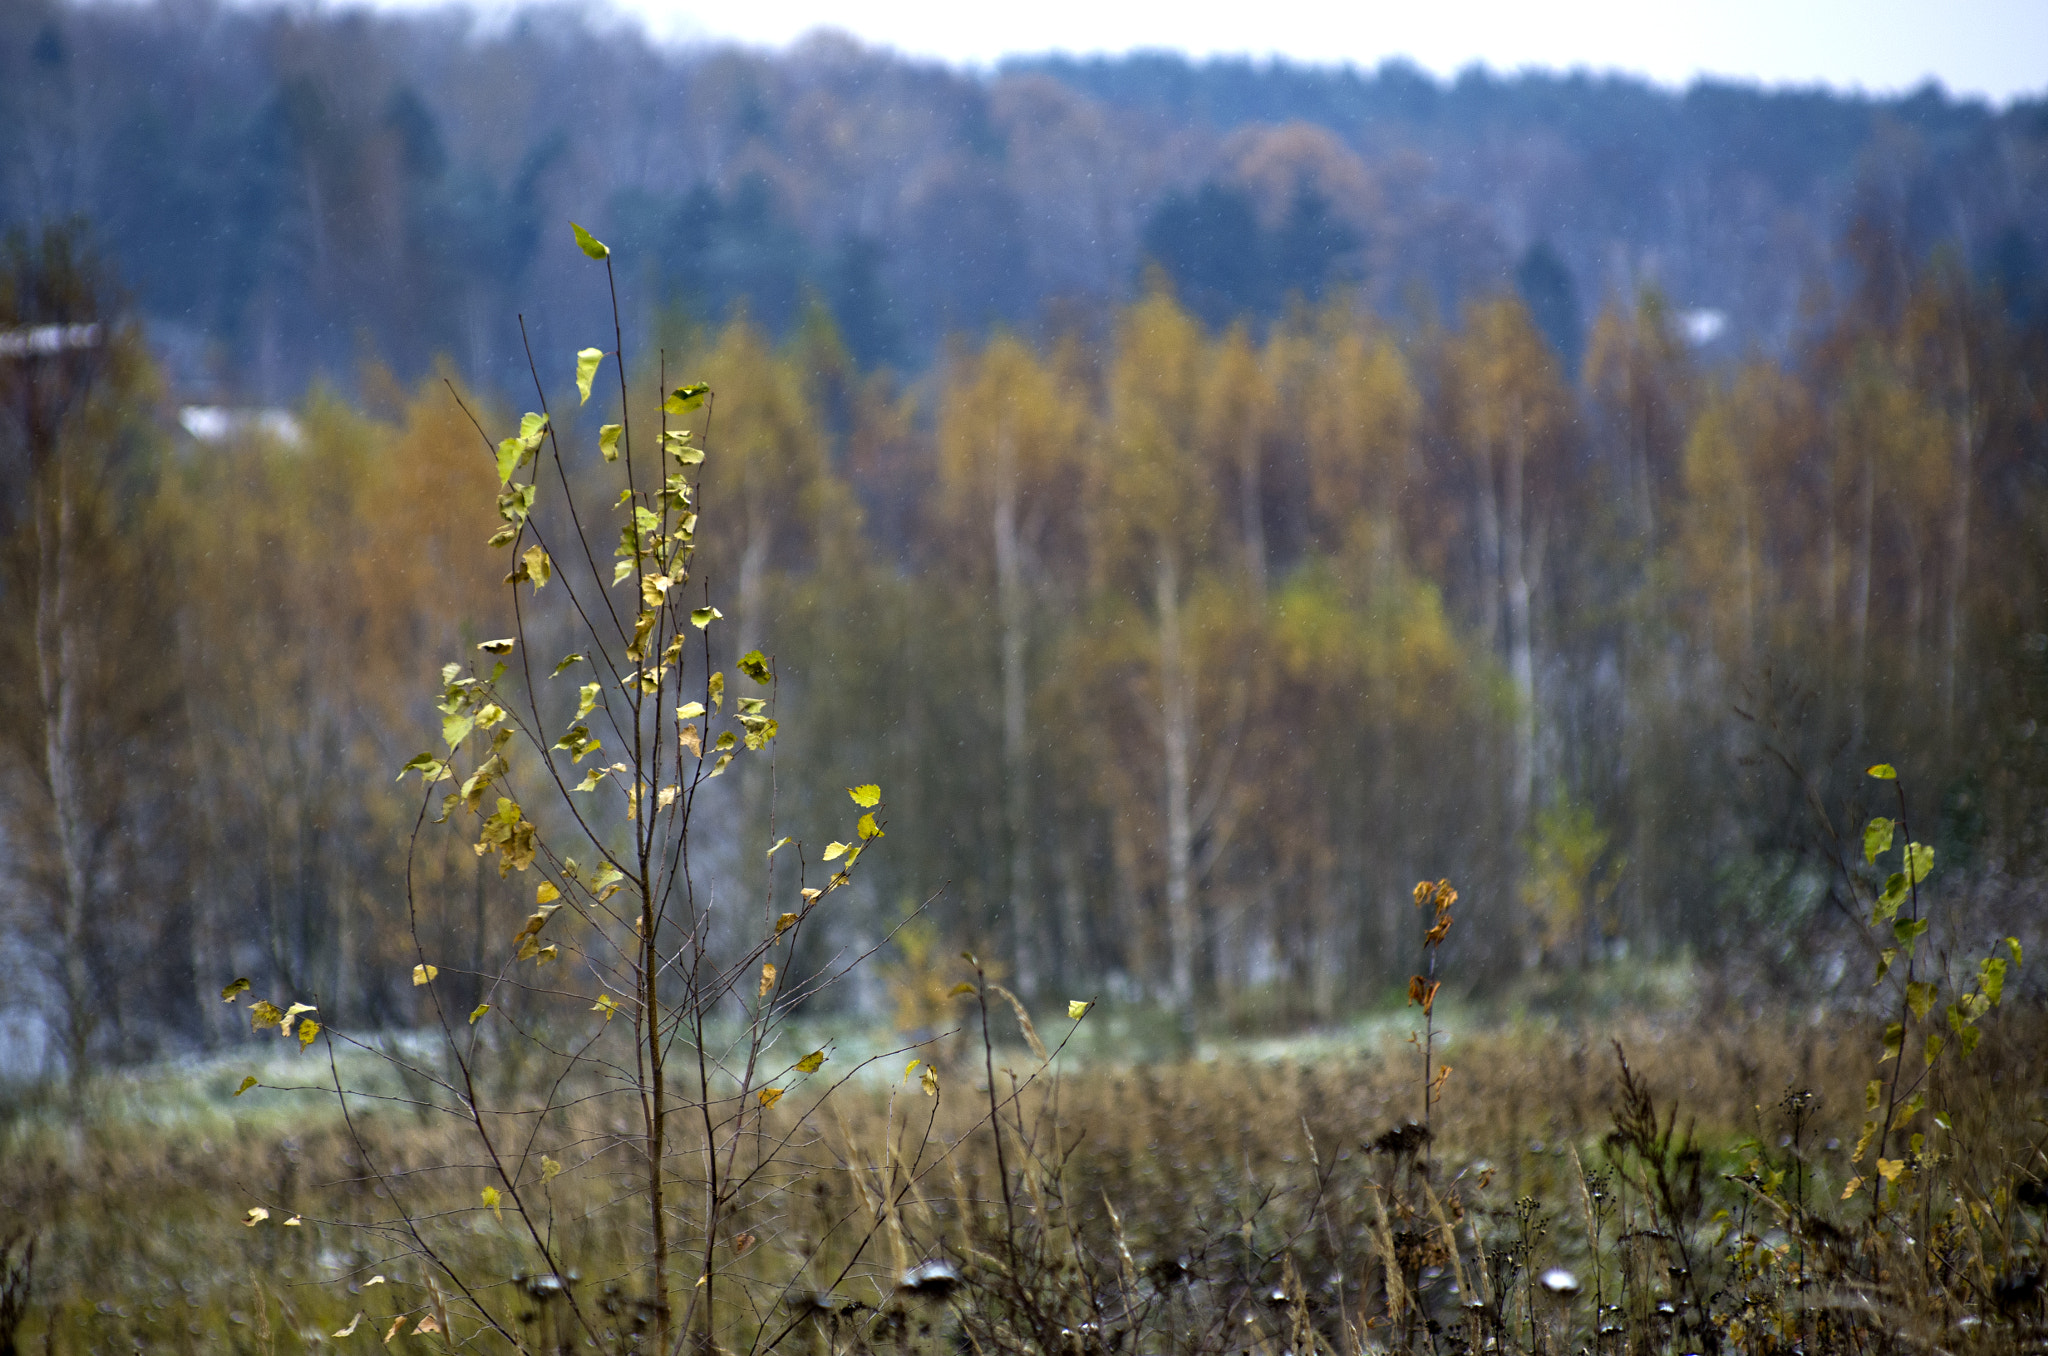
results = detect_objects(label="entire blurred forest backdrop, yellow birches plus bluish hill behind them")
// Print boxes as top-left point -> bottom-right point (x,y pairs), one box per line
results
0,2 -> 2048,1069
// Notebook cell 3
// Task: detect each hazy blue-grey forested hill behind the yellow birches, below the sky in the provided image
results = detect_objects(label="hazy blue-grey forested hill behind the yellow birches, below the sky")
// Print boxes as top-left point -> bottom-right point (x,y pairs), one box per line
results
0,0 -> 2048,404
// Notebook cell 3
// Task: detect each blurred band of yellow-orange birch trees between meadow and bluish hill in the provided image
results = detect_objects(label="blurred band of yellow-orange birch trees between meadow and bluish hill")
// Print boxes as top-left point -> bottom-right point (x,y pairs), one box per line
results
0,219 -> 2048,1067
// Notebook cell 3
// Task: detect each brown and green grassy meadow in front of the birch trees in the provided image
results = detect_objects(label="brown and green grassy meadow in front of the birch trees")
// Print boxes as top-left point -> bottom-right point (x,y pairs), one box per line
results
0,966 -> 2048,1356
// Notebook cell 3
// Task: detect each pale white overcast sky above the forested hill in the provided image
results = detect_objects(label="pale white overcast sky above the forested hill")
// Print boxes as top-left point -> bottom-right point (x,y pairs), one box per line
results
373,0 -> 2048,100
